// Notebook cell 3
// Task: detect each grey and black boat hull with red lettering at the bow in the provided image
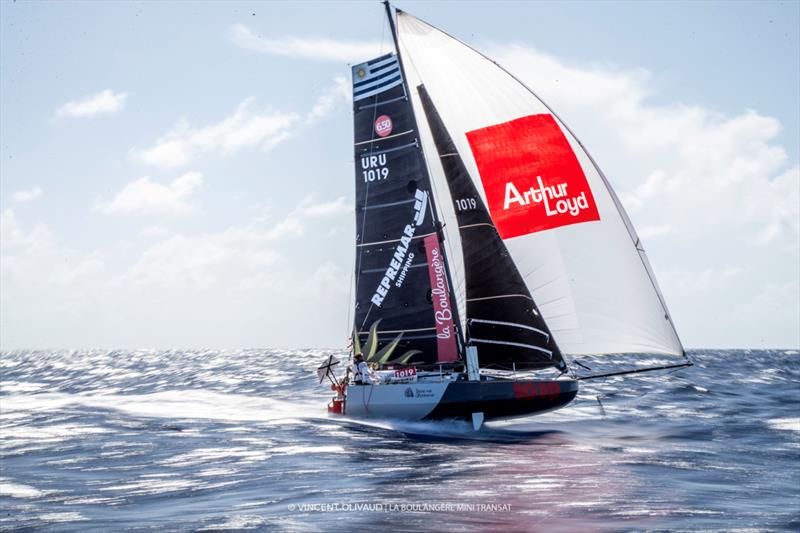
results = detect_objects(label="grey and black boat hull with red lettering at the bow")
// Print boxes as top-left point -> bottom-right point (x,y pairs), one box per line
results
344,380 -> 578,420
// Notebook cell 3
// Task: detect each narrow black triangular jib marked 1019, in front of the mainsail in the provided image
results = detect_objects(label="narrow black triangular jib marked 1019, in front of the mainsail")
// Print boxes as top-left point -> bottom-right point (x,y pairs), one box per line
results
418,85 -> 566,370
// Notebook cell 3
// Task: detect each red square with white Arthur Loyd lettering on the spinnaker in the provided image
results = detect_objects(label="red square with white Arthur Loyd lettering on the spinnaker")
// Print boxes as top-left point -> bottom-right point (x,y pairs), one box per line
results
467,114 -> 600,239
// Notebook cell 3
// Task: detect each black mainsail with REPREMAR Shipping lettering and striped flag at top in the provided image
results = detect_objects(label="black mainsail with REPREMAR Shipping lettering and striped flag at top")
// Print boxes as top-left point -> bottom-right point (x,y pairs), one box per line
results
353,54 -> 460,363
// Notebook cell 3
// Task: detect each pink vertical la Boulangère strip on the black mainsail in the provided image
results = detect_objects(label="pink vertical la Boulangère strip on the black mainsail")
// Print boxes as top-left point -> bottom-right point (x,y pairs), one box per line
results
425,234 -> 458,362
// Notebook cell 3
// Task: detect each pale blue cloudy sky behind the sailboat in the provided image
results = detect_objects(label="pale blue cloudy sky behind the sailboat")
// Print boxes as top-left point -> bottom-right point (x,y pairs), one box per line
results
0,1 -> 800,350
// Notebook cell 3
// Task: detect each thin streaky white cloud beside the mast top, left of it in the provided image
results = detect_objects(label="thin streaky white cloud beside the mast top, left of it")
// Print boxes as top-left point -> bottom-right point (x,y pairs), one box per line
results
230,24 -> 388,63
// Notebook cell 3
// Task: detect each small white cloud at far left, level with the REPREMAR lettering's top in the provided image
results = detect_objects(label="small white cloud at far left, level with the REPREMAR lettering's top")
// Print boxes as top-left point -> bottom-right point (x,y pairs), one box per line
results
95,172 -> 203,215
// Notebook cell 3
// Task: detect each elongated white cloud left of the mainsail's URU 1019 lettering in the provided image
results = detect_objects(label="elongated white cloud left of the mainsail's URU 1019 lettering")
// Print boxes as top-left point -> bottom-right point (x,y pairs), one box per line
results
133,98 -> 299,168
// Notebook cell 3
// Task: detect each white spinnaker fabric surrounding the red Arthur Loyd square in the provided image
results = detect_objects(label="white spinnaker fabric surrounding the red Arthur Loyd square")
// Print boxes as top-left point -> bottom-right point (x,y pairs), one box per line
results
397,11 -> 684,355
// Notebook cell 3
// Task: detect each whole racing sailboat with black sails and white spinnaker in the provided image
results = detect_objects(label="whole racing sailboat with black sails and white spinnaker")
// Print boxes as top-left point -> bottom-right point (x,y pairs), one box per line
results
318,2 -> 691,430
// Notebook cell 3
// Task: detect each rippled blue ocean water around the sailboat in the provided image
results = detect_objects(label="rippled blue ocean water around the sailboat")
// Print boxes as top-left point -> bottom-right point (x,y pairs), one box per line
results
0,350 -> 800,532
